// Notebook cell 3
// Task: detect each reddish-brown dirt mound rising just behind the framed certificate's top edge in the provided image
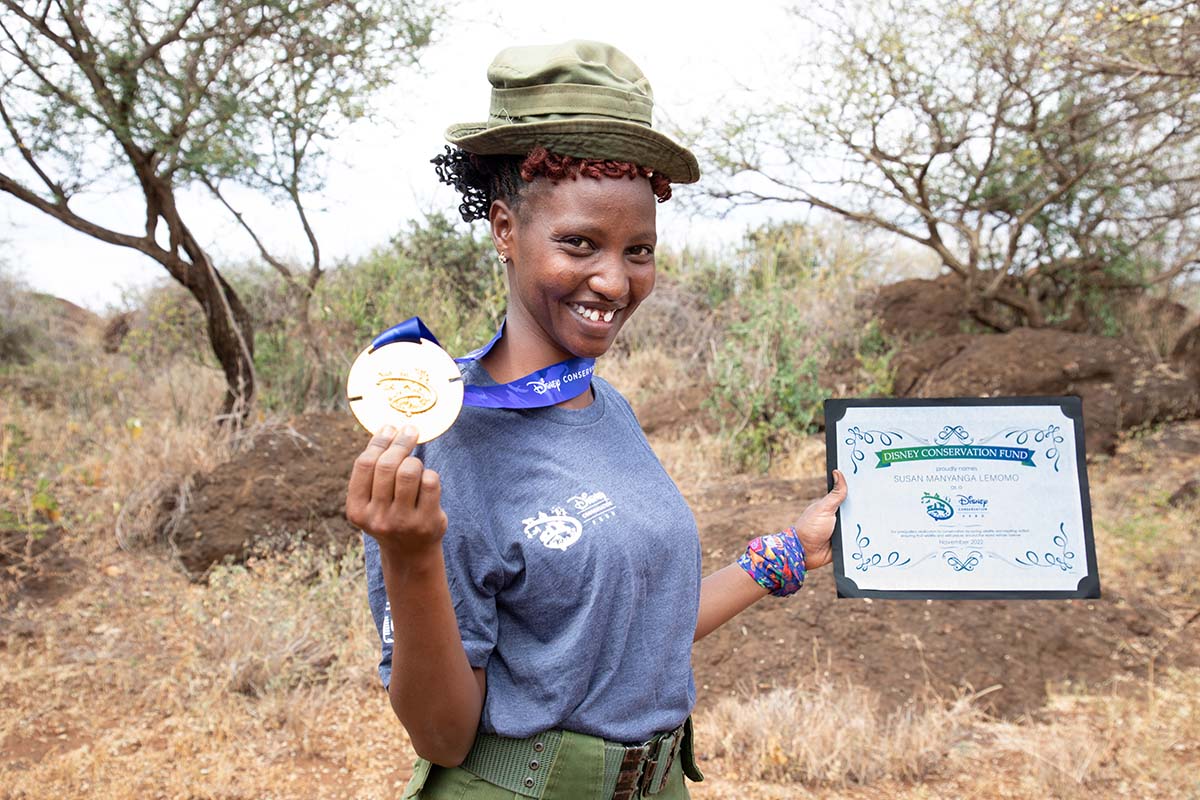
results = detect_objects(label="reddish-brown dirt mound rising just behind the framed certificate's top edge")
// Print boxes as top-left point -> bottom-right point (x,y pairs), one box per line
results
894,327 -> 1200,453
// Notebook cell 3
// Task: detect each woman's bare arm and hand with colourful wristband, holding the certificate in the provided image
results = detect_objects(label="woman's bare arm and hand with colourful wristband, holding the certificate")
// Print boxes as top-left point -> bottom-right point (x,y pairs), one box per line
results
692,470 -> 846,642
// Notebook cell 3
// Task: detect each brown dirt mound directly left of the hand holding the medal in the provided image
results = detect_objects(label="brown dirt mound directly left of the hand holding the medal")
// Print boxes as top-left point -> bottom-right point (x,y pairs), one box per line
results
169,414 -> 367,577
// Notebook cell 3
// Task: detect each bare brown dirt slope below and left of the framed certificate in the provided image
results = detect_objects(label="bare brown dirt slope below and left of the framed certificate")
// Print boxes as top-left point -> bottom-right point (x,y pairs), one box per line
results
690,480 -> 1196,716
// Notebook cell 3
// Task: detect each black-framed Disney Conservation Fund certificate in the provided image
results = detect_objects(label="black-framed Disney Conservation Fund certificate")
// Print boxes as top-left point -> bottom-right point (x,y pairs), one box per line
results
824,397 -> 1100,600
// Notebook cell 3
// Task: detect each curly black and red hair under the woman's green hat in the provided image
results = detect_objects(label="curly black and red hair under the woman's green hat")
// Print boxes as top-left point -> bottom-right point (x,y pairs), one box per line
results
432,145 -> 671,222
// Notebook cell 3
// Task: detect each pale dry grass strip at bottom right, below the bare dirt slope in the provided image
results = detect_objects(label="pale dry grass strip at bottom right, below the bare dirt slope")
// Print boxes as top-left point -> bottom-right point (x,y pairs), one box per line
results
695,670 -> 1200,800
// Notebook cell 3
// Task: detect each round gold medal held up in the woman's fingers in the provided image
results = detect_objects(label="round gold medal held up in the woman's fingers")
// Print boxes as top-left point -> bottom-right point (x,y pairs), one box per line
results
346,339 -> 463,444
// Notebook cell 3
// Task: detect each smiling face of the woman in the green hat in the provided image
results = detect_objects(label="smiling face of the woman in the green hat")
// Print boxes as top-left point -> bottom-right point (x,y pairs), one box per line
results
491,176 -> 658,361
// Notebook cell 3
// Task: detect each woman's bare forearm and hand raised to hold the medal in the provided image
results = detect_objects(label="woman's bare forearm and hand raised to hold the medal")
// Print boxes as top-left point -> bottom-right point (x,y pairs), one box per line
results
346,427 -> 485,766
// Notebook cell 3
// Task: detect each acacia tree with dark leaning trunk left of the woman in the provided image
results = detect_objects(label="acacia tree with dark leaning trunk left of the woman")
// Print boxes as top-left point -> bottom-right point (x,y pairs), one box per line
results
0,0 -> 439,420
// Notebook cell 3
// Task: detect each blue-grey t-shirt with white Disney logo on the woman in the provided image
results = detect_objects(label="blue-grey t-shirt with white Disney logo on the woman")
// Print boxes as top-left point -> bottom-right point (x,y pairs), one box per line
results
364,363 -> 701,742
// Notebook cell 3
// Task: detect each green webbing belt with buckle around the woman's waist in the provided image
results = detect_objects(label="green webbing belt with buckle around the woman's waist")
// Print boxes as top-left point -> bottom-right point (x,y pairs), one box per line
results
462,722 -> 688,800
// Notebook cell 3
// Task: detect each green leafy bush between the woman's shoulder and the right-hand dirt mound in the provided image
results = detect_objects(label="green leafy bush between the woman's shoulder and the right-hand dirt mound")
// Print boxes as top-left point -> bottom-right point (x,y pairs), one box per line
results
695,223 -> 895,470
